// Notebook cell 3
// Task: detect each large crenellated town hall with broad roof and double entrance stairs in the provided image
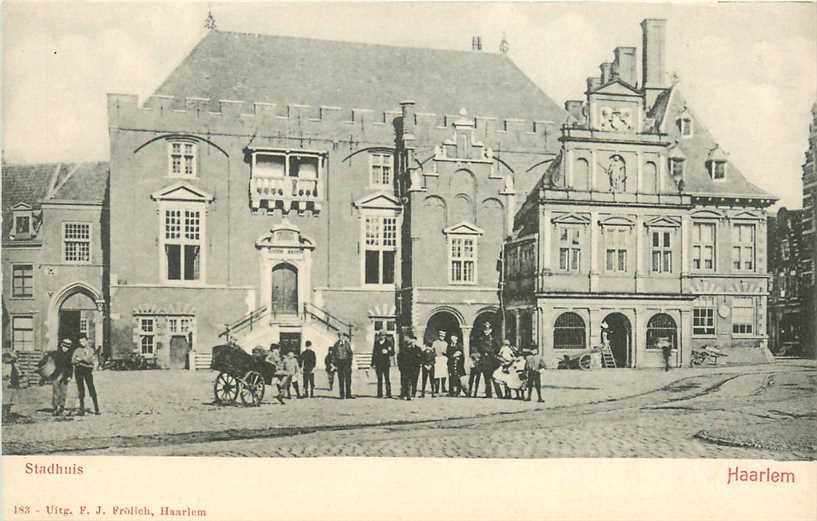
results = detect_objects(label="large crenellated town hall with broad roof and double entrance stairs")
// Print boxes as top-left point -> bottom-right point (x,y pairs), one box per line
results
108,30 -> 566,368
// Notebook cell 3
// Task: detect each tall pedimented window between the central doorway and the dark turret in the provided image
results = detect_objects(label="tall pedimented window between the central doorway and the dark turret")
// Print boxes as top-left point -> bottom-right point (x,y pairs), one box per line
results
363,215 -> 397,284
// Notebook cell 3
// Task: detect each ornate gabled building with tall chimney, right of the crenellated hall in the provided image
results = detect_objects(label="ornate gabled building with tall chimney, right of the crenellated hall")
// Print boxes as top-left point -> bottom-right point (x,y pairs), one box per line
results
503,19 -> 776,367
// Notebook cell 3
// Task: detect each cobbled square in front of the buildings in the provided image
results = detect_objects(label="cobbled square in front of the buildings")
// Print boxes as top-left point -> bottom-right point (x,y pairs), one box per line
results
3,361 -> 817,459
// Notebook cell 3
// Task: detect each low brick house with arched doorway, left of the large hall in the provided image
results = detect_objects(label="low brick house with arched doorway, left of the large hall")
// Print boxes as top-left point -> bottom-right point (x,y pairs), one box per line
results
2,162 -> 108,378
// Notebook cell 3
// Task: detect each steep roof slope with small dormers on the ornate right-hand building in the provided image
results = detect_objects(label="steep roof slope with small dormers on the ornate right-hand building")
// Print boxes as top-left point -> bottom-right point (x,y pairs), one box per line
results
651,85 -> 777,200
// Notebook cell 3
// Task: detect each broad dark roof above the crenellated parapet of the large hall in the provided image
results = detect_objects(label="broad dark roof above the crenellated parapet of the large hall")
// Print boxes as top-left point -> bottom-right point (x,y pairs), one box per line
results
150,31 -> 566,123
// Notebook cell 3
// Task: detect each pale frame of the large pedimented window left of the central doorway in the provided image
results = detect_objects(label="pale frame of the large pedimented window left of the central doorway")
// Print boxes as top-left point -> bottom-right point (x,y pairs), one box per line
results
159,201 -> 207,286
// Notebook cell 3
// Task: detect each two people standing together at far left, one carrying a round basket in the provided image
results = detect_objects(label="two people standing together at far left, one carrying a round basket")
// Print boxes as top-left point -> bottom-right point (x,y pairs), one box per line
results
47,333 -> 101,416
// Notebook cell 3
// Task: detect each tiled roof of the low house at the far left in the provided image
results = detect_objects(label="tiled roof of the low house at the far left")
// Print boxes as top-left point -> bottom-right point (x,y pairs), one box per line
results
2,162 -> 108,237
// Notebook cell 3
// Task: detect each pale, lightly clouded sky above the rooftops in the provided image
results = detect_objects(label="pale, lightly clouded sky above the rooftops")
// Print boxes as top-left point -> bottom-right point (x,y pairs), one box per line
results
2,1 -> 817,208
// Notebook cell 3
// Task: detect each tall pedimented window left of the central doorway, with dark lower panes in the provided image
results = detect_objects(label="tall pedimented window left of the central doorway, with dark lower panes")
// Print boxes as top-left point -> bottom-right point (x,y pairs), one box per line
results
164,208 -> 204,280
